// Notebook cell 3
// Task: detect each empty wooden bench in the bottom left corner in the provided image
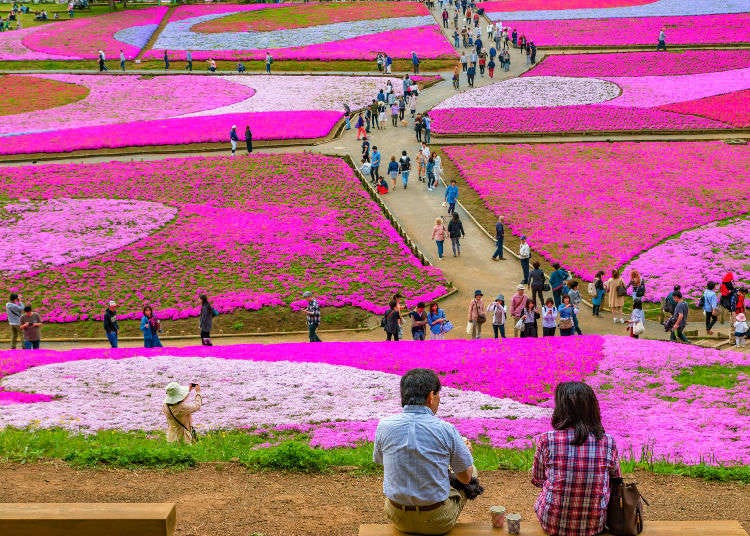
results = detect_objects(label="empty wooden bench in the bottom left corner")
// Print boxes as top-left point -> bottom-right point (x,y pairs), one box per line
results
0,503 -> 176,536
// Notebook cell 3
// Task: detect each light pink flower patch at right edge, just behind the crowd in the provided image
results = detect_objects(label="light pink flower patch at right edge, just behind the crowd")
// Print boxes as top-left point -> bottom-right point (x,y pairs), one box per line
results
625,216 -> 750,302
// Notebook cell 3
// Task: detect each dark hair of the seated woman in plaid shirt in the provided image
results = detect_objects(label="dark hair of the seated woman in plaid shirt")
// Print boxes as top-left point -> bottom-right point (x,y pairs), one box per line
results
552,382 -> 604,445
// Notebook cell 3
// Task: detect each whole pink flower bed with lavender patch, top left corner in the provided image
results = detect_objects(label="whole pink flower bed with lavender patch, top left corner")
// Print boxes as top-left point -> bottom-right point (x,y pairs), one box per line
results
0,6 -> 167,60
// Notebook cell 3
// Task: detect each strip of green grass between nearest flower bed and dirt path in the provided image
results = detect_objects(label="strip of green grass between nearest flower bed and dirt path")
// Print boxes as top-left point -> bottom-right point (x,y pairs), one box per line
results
0,428 -> 750,484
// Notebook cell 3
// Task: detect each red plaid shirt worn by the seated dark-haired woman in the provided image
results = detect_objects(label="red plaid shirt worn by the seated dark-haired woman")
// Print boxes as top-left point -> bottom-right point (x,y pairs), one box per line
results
531,429 -> 620,536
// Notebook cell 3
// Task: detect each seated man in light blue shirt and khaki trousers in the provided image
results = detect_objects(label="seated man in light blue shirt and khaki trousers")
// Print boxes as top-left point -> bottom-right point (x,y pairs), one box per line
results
373,369 -> 476,534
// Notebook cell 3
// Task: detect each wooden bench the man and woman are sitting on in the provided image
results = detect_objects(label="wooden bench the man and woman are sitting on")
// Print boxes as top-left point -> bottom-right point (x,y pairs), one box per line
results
359,514 -> 748,536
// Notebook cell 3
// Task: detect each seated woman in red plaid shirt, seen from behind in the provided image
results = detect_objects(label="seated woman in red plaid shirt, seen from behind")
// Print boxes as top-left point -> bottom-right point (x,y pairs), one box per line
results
531,382 -> 620,536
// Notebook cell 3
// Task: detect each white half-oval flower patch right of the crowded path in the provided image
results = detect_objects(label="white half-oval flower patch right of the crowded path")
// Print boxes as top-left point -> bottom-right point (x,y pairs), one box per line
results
435,76 -> 620,110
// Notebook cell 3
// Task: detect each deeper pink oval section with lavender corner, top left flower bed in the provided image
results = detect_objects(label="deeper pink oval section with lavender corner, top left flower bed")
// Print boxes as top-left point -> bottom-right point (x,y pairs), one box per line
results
19,6 -> 168,59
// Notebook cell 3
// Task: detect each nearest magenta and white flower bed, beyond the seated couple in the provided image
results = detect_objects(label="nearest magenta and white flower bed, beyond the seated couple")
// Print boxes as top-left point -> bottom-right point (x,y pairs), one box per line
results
0,336 -> 750,464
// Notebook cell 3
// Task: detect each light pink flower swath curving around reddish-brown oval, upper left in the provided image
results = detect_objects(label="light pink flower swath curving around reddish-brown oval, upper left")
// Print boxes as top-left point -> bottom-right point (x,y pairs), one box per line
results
0,74 -> 255,136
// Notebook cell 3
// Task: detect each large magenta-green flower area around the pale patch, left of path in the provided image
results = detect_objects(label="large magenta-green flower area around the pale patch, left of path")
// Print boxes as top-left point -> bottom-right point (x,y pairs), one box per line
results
0,154 -> 446,322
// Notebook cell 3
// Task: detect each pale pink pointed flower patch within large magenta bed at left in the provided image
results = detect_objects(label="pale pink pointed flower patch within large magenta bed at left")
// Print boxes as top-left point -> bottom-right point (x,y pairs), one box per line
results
0,199 -> 177,275
